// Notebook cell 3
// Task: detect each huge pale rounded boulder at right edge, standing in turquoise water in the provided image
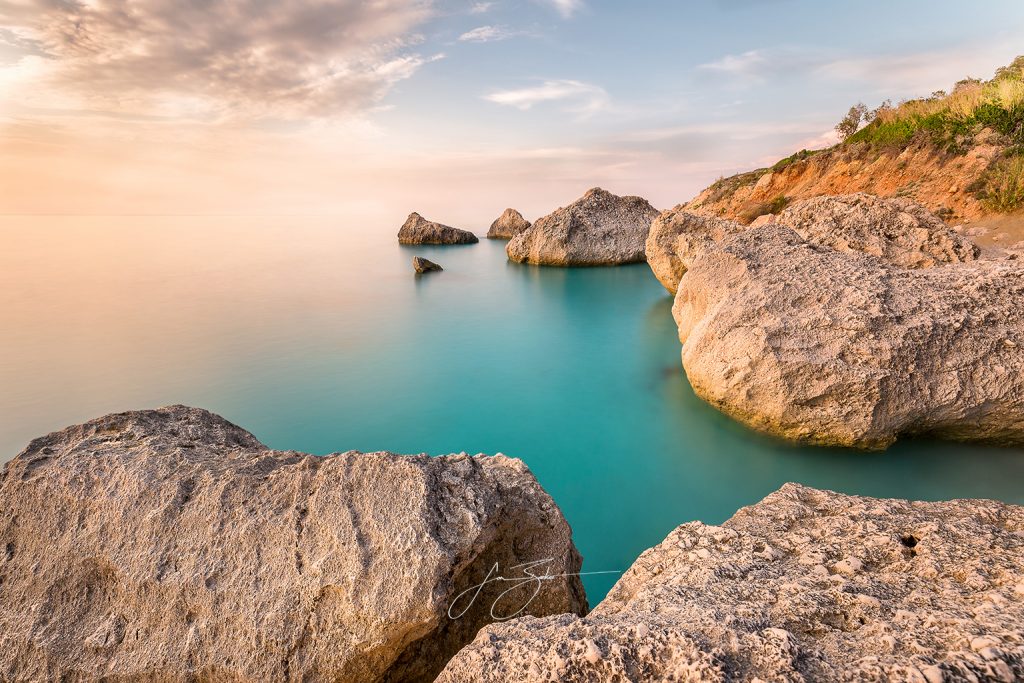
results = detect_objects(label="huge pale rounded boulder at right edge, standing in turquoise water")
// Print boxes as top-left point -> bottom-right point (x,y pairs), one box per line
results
673,224 -> 1024,447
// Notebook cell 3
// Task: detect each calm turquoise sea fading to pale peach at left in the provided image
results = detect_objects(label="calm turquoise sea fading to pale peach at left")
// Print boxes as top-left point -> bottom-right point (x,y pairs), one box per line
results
0,217 -> 1024,604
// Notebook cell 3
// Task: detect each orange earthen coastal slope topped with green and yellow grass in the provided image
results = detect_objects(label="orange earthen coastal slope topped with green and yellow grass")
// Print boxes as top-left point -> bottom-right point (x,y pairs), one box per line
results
686,57 -> 1024,232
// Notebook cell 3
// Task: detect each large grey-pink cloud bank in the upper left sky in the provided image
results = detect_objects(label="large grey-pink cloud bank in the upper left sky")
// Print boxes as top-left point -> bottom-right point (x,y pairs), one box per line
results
0,0 -> 436,117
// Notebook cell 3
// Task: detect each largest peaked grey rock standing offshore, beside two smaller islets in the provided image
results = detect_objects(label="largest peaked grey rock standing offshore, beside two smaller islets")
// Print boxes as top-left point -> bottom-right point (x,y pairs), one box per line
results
505,187 -> 657,265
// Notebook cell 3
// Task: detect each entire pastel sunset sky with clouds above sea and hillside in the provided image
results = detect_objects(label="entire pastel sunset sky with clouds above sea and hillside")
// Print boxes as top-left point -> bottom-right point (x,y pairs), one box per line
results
0,0 -> 1024,227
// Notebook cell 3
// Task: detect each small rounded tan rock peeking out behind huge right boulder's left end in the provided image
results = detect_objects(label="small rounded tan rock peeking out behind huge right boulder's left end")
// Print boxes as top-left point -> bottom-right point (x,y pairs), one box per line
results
646,204 -> 746,295
